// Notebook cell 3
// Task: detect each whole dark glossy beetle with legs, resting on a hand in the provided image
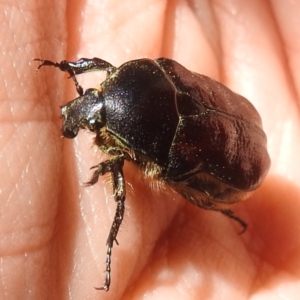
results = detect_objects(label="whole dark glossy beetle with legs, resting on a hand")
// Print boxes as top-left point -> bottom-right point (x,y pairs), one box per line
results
37,58 -> 270,291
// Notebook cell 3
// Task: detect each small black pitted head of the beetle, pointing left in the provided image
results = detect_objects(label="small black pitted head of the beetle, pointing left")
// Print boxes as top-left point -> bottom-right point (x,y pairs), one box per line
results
61,89 -> 105,139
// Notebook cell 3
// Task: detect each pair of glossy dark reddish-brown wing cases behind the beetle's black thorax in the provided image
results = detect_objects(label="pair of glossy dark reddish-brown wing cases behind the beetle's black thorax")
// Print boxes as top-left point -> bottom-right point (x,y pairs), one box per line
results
152,58 -> 270,191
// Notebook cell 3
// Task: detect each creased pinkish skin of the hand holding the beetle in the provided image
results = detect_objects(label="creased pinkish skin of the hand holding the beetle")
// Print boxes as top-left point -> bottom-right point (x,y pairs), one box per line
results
0,0 -> 300,300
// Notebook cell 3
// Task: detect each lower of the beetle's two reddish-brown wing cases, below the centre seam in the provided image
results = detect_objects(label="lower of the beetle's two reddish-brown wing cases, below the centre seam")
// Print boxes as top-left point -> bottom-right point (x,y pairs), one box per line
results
167,111 -> 269,191
